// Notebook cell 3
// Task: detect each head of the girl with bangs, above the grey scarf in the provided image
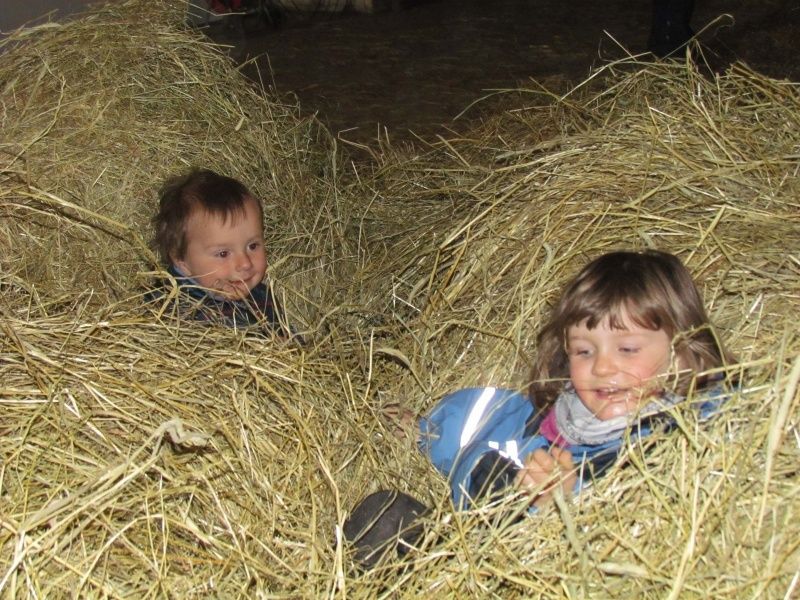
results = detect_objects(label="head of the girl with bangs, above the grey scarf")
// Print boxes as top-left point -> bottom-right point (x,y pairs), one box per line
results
531,250 -> 728,418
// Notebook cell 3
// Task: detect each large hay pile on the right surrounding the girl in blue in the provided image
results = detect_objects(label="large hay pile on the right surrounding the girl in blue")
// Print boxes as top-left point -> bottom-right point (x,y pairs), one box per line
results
348,57 -> 800,597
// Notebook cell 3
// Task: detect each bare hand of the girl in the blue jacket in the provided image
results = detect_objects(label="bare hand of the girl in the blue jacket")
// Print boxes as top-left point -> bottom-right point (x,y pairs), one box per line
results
514,446 -> 578,506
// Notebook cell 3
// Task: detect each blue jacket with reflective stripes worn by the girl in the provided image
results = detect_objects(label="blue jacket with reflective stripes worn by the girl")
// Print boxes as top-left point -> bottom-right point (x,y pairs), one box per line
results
419,387 -> 722,509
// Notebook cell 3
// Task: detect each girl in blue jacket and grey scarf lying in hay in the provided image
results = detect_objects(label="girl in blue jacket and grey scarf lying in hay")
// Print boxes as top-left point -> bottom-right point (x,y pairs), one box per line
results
345,251 -> 730,560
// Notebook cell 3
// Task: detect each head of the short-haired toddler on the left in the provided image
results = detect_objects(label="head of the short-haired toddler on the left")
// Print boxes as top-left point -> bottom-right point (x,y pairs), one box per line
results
153,169 -> 267,300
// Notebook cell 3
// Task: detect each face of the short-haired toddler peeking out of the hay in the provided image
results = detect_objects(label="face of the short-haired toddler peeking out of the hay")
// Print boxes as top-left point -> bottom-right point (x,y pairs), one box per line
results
173,198 -> 267,300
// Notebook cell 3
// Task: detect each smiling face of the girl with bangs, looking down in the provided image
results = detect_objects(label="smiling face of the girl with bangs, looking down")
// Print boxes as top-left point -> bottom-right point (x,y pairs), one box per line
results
567,314 -> 672,421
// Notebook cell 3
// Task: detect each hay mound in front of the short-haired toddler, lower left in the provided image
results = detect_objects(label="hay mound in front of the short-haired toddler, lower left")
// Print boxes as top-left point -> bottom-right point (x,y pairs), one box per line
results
0,311 -> 422,597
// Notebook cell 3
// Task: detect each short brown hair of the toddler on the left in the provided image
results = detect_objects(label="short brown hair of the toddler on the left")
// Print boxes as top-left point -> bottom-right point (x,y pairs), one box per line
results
153,169 -> 263,264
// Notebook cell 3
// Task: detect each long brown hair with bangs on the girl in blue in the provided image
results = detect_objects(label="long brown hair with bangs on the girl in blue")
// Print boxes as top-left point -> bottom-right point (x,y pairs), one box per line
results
530,250 -> 732,409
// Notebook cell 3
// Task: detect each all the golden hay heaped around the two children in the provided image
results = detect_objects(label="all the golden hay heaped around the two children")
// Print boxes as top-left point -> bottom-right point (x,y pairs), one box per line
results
0,0 -> 800,598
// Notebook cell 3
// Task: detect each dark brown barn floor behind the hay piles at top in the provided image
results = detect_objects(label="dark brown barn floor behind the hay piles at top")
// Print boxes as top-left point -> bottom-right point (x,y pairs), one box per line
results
209,0 -> 800,150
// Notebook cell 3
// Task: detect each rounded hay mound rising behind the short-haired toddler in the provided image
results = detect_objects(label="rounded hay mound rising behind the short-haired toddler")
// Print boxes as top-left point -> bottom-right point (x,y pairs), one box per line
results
0,0 -> 347,318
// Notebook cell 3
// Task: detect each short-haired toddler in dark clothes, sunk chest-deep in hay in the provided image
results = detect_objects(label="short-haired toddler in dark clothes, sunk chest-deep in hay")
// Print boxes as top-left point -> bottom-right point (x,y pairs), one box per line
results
151,169 -> 286,333
